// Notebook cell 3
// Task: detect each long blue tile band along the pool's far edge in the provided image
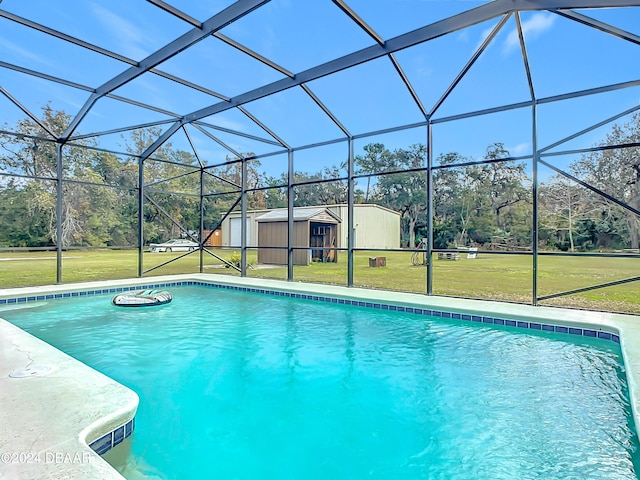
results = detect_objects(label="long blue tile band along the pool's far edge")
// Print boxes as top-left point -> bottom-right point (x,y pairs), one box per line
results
0,280 -> 620,344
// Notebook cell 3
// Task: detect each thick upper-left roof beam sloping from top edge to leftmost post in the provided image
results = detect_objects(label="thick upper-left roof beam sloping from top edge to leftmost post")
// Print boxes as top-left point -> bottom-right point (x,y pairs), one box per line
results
62,0 -> 269,140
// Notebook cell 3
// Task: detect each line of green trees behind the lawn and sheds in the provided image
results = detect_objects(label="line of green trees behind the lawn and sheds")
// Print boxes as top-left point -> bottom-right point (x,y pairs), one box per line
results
0,107 -> 640,251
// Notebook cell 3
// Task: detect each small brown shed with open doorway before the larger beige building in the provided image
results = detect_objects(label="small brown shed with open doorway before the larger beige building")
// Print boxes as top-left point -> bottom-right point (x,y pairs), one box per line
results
256,207 -> 341,265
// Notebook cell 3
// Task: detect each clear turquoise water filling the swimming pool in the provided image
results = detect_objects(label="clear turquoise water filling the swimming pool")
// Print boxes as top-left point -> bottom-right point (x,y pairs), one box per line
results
0,286 -> 638,480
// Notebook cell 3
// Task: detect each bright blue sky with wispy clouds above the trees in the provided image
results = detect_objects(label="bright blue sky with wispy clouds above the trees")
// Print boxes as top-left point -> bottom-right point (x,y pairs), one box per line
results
0,0 -> 640,179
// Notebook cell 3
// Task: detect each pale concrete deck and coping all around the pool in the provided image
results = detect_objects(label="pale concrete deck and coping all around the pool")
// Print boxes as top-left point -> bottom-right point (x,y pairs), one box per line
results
0,274 -> 640,480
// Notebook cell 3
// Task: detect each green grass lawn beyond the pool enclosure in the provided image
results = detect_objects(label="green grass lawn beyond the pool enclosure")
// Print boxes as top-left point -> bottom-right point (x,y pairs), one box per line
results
0,249 -> 640,313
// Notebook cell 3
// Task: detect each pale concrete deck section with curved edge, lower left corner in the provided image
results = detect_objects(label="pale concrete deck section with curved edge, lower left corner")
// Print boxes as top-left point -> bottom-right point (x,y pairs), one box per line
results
0,312 -> 139,480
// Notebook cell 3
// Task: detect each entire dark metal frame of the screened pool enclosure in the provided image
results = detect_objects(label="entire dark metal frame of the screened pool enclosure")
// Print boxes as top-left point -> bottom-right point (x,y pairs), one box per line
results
0,0 -> 640,305
